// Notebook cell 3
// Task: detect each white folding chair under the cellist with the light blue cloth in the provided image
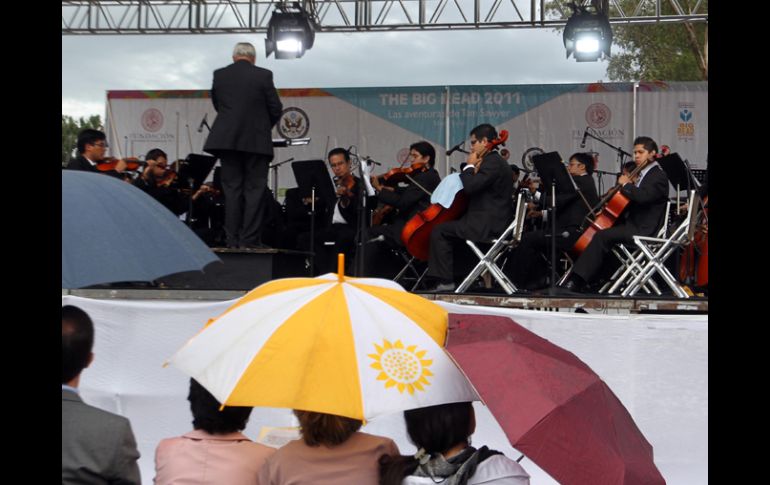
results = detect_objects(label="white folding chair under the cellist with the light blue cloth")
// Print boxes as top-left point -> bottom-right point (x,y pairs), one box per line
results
455,193 -> 527,295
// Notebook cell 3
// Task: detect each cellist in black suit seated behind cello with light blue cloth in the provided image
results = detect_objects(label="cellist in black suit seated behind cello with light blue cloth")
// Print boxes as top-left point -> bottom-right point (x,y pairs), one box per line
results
425,123 -> 513,292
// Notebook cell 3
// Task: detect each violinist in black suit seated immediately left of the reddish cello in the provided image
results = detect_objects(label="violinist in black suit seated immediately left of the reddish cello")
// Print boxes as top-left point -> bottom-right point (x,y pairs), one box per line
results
364,141 -> 441,278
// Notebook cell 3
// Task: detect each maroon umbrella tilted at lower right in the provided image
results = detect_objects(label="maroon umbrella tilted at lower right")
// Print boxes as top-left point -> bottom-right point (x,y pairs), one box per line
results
447,314 -> 666,485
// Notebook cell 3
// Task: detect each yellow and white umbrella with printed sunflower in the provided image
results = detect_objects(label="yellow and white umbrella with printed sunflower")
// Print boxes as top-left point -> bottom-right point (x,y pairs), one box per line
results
169,258 -> 478,420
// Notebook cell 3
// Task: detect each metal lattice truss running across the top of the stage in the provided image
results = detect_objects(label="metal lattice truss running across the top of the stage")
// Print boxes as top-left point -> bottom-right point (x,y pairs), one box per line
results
62,0 -> 708,35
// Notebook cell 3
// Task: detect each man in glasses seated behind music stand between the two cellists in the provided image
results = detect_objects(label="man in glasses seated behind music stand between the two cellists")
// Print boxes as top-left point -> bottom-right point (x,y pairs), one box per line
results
506,153 -> 599,289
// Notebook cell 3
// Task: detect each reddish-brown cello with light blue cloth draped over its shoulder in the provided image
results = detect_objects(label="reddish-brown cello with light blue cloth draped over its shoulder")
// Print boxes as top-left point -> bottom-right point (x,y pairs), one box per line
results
401,130 -> 508,261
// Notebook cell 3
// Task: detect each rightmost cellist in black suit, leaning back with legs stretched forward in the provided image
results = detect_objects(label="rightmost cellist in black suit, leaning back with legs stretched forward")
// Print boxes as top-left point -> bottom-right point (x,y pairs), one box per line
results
562,136 -> 668,292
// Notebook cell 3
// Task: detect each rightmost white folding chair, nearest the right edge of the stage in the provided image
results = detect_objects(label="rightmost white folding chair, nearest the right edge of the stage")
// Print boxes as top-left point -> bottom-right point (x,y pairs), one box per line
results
621,190 -> 700,298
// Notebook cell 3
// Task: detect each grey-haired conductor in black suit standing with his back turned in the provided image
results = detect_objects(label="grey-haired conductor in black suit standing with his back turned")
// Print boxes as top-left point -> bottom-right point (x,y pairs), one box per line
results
203,42 -> 283,248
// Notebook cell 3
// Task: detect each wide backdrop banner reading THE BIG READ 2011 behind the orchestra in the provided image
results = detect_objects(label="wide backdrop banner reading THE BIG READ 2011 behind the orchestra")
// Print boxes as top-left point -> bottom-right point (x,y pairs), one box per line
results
106,82 -> 708,199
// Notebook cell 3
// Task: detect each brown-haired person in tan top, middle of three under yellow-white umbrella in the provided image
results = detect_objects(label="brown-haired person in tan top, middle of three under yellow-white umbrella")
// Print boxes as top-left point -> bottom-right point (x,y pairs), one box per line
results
259,410 -> 399,485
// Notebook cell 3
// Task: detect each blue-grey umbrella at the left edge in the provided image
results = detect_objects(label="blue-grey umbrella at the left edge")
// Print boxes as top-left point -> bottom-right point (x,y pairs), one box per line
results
61,170 -> 220,288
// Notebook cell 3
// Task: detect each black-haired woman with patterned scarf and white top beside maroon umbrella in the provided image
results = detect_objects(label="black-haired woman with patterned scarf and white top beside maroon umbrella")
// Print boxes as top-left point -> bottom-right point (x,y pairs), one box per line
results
380,402 -> 529,485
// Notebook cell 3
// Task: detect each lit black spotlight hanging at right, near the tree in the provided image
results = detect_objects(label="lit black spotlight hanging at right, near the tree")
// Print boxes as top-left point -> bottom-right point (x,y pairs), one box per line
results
564,4 -> 612,62
